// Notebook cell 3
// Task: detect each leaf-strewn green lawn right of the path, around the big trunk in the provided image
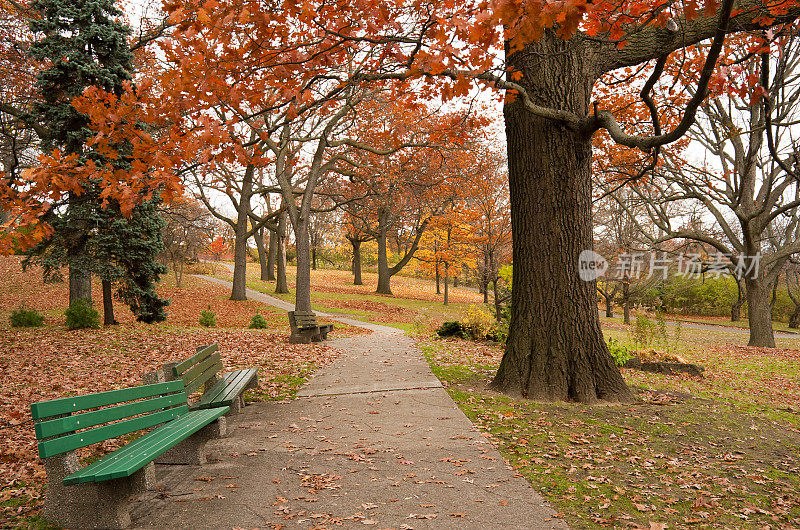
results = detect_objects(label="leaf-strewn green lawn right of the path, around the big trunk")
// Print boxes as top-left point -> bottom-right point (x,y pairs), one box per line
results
419,324 -> 800,528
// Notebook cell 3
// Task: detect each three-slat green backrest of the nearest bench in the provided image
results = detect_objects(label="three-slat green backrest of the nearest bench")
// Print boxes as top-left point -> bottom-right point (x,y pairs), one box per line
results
31,381 -> 188,458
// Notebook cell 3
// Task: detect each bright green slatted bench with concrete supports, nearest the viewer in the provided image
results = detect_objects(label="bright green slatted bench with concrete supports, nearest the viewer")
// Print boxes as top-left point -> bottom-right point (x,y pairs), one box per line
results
31,381 -> 228,528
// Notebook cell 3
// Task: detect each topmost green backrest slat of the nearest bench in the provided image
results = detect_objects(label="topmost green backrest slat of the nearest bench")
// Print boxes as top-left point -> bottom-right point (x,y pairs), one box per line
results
31,381 -> 183,420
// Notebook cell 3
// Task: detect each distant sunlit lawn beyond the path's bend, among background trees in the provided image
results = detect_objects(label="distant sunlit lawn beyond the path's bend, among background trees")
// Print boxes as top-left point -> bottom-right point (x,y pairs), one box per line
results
208,263 -> 483,324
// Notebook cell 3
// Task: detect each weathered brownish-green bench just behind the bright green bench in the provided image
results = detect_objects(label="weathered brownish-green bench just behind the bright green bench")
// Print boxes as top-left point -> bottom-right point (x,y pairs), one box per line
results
145,344 -> 258,414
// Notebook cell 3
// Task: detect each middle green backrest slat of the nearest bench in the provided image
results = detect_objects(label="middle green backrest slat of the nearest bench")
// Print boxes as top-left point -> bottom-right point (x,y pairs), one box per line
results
35,393 -> 186,440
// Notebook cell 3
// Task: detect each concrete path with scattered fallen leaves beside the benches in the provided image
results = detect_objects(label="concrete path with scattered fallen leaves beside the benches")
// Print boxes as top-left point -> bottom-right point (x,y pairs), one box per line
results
133,276 -> 567,530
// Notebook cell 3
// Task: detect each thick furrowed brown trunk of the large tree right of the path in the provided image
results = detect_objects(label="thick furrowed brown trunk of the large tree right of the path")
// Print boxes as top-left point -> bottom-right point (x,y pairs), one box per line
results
492,32 -> 632,403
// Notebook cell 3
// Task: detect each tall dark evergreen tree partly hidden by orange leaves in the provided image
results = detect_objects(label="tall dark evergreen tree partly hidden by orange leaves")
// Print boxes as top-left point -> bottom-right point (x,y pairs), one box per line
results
26,0 -> 169,324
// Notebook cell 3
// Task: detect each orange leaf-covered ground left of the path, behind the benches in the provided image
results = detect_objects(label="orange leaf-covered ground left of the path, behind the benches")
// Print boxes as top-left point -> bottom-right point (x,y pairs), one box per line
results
0,256 -> 350,528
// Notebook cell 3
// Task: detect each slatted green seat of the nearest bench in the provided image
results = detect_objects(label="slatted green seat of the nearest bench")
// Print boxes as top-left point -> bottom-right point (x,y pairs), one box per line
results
64,407 -> 229,485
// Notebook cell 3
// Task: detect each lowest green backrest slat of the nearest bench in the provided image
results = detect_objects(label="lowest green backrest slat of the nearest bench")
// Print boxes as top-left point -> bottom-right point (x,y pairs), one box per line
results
39,402 -> 189,458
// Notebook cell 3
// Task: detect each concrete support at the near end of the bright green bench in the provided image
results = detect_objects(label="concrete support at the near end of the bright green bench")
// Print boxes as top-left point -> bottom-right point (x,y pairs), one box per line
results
42,452 -> 155,528
